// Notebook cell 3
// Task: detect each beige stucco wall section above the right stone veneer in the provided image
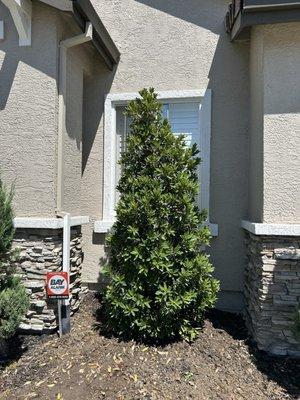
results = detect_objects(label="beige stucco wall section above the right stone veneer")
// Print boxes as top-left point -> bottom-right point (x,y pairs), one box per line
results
264,23 -> 300,223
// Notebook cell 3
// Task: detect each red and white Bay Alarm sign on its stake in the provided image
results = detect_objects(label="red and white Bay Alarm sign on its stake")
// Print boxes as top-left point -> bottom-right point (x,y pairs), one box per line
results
47,272 -> 70,336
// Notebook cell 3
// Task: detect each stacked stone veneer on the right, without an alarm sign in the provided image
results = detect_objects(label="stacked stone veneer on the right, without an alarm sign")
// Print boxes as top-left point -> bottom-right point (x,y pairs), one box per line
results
245,233 -> 300,357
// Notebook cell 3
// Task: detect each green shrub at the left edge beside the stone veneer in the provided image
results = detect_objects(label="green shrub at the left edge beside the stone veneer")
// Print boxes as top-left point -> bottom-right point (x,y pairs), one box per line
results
0,179 -> 29,339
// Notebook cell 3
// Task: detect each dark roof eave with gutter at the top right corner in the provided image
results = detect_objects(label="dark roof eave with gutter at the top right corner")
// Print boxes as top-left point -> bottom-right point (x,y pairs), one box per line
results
225,0 -> 300,40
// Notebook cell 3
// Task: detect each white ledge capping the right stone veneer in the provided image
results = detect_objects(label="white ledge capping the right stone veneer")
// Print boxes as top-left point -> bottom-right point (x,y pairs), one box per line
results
242,221 -> 300,236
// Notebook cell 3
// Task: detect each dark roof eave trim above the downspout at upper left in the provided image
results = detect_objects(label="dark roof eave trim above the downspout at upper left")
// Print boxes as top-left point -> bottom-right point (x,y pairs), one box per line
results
72,0 -> 120,70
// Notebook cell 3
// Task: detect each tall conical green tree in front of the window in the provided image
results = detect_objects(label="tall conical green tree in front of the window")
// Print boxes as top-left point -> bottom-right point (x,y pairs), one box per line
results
104,89 -> 219,341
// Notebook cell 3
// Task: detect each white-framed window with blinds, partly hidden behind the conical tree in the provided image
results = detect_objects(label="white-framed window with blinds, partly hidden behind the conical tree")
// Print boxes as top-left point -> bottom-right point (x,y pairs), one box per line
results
94,90 -> 218,236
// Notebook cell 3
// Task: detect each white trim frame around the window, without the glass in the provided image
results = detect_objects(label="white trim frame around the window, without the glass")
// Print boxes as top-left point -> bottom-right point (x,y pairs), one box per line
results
94,88 -> 218,236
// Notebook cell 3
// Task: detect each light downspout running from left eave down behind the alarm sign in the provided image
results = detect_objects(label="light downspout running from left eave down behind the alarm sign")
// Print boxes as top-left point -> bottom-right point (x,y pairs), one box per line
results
56,22 -> 93,335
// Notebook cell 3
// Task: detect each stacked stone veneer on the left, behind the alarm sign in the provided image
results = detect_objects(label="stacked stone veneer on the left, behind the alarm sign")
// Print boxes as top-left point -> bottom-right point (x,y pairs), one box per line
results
14,227 -> 83,334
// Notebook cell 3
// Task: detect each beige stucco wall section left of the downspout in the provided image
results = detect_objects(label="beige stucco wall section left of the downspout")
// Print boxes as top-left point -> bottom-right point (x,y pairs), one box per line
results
0,2 -> 57,217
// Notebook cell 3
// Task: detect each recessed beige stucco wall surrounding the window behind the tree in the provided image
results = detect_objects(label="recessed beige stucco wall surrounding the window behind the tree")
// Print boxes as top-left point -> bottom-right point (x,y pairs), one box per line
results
83,0 -> 249,308
